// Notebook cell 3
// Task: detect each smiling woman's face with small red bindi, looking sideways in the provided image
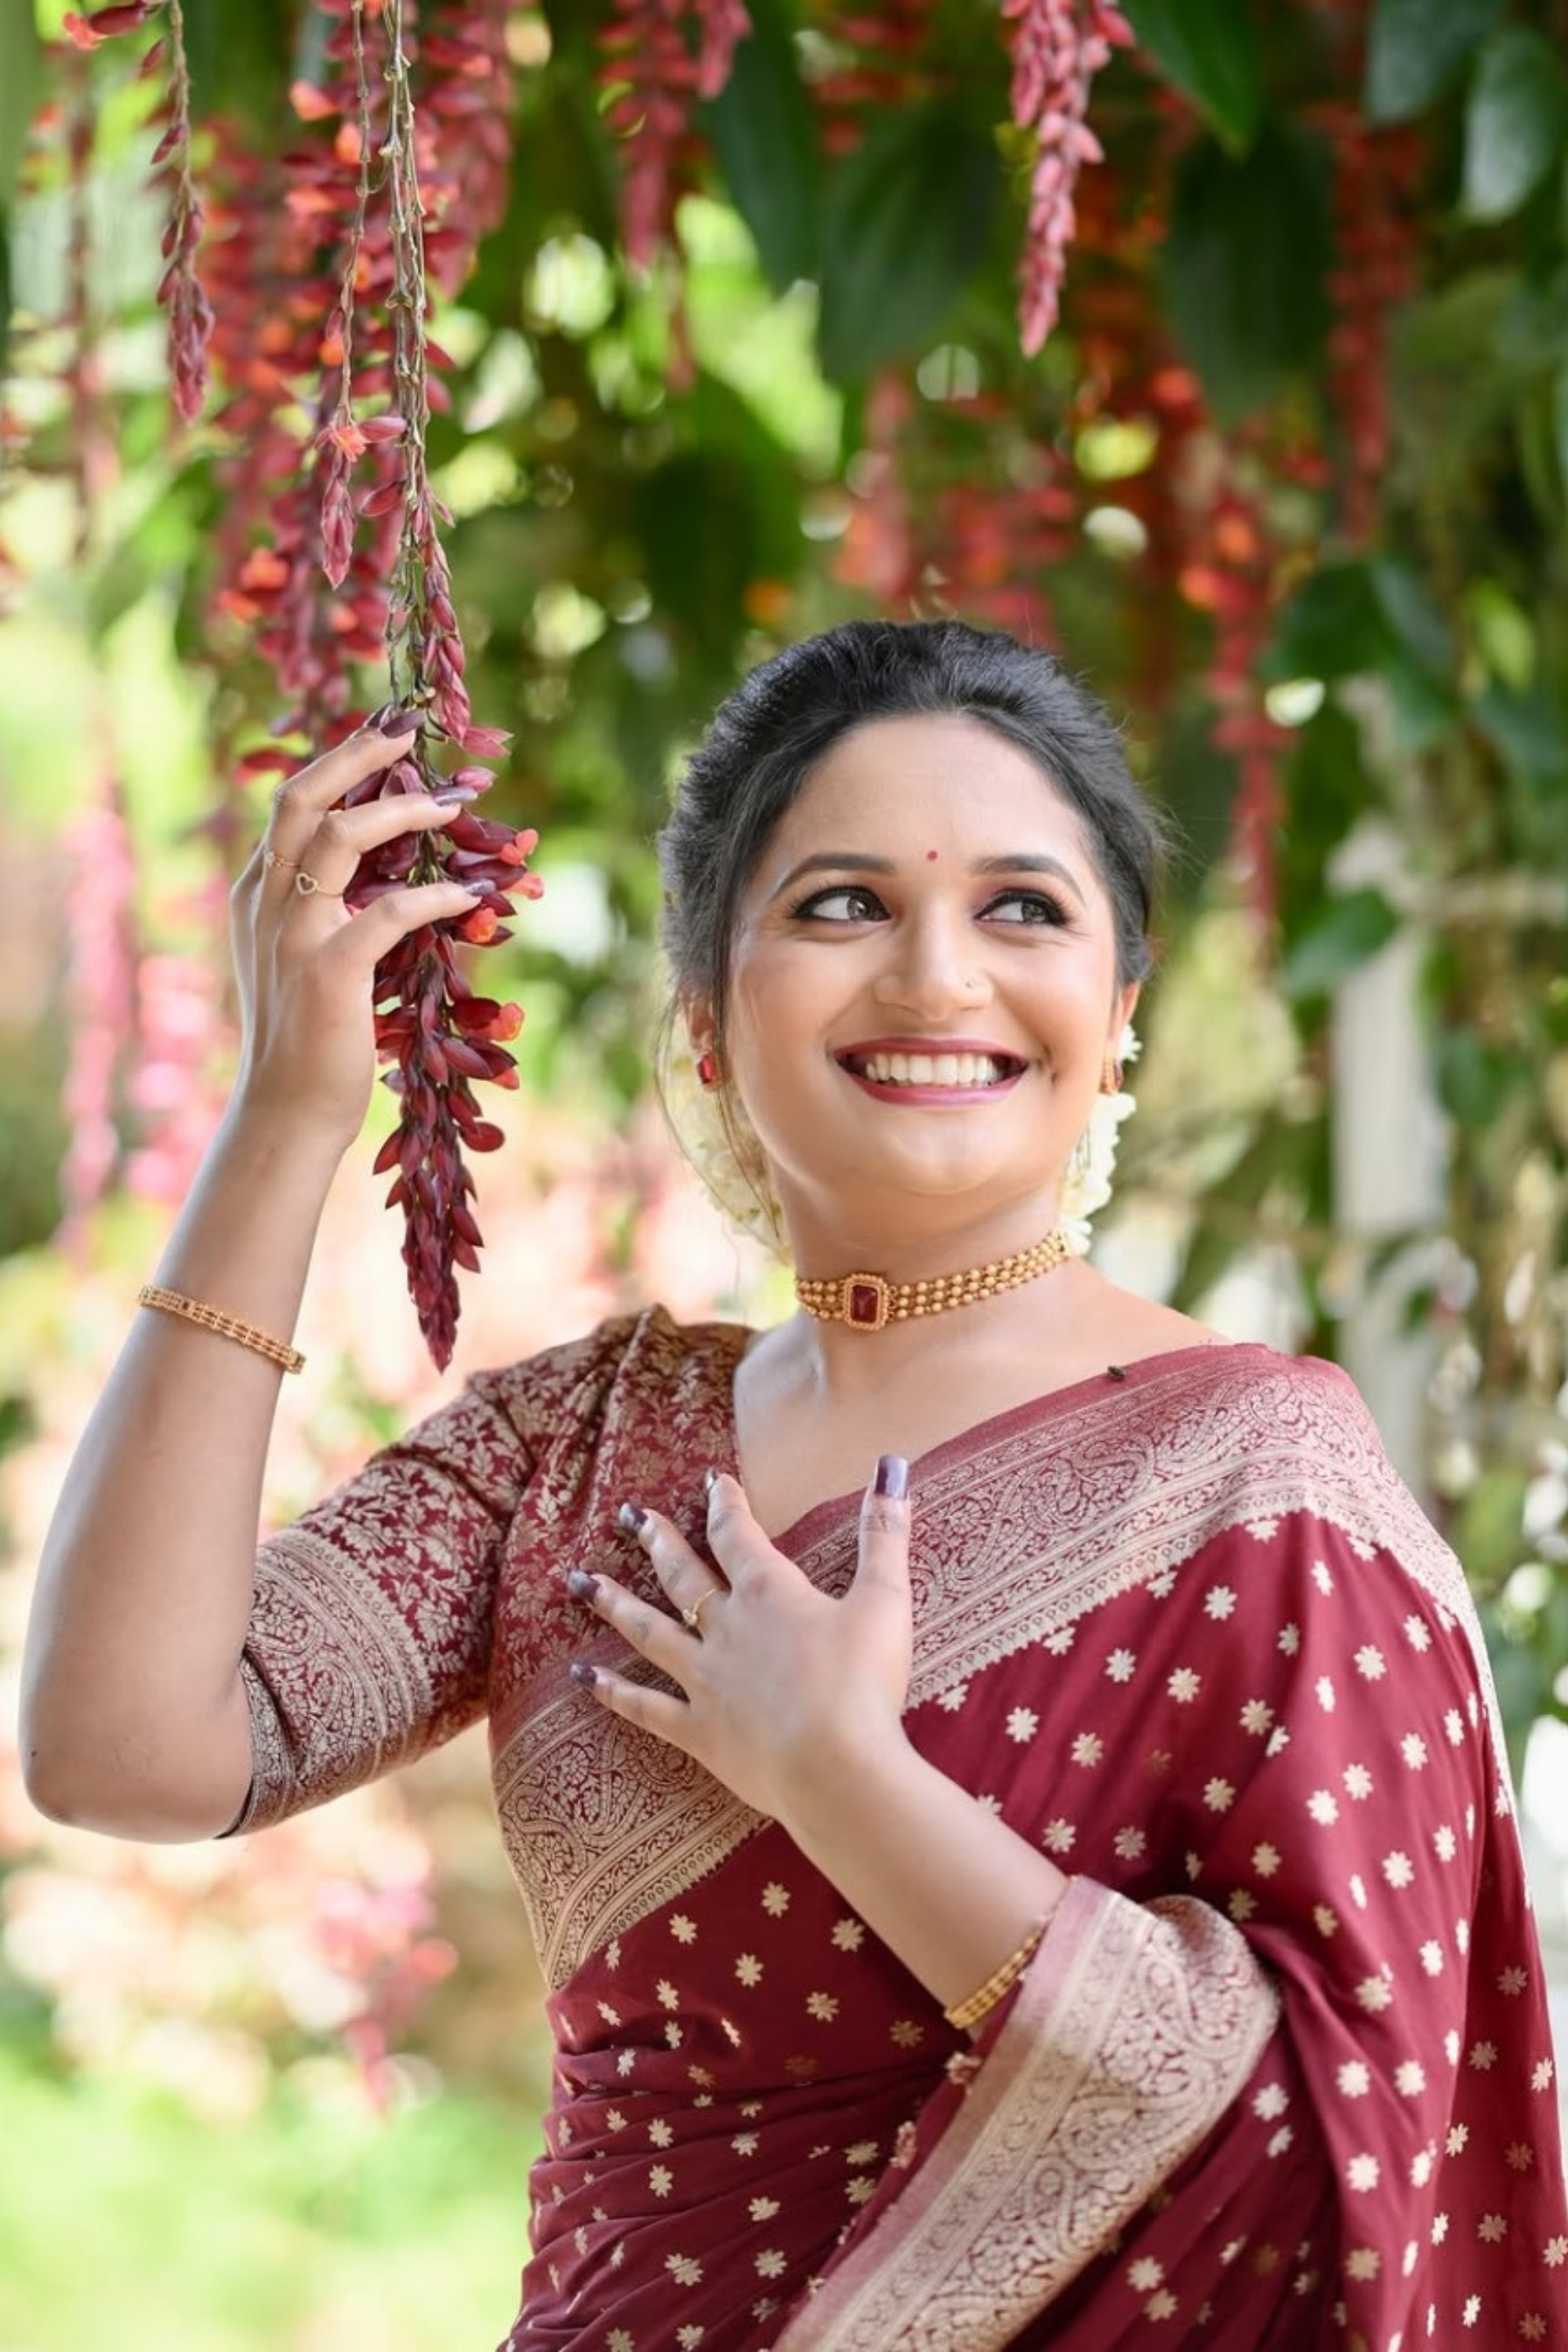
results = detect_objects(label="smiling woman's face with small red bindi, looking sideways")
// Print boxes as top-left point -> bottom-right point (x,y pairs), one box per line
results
694,715 -> 1138,1240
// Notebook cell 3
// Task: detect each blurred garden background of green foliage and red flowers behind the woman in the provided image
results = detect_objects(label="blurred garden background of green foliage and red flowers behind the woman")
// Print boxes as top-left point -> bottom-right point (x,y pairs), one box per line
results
0,0 -> 1568,2352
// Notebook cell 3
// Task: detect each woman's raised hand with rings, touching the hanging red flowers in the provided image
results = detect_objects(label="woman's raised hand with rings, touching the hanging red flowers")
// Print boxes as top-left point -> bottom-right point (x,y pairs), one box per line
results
230,713 -> 484,1145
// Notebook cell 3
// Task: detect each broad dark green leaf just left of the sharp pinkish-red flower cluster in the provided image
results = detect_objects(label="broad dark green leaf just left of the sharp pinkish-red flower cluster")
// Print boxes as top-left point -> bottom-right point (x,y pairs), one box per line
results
818,106 -> 1001,383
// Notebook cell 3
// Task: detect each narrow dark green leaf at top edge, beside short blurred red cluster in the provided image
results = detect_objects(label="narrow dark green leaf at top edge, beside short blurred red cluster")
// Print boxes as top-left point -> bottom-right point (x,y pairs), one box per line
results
703,0 -> 822,294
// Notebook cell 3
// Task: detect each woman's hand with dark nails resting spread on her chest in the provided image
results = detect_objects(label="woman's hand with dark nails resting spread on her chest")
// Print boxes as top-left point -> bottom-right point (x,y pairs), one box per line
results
569,1456 -> 912,1830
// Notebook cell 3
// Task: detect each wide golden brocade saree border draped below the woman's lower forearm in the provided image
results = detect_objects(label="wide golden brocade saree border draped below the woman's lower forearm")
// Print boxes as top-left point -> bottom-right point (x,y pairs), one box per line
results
774,1879 -> 1279,2352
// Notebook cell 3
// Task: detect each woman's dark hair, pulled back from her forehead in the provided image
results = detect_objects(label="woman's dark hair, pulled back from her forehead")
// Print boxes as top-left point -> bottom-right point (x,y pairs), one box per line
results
659,621 -> 1163,1025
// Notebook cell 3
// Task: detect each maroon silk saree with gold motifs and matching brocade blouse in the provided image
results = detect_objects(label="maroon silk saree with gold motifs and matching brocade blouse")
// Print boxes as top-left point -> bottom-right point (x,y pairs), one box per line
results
242,1310 -> 1568,2352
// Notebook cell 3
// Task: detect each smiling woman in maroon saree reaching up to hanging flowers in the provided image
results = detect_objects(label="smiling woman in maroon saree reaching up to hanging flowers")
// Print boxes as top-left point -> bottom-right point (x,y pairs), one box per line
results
24,623 -> 1568,2352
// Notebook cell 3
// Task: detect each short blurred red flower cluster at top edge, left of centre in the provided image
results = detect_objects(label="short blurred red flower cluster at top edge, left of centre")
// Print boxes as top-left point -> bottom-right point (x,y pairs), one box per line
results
600,0 -> 753,268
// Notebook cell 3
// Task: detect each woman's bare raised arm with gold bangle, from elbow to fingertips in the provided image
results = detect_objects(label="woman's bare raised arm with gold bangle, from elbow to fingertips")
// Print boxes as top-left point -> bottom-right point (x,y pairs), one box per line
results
21,717 -> 484,1839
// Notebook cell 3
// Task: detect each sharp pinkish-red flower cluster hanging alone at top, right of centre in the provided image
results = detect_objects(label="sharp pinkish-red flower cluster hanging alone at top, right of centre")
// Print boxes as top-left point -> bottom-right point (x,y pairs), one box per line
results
1001,0 -> 1133,358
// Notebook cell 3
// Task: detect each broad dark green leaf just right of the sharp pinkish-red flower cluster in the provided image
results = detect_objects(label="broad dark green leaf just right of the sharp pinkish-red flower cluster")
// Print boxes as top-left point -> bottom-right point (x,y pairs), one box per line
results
1163,125 -> 1328,423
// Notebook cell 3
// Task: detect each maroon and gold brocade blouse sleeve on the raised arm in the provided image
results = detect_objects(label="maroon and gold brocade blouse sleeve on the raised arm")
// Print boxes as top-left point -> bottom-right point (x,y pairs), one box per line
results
226,1374 -> 534,1837
